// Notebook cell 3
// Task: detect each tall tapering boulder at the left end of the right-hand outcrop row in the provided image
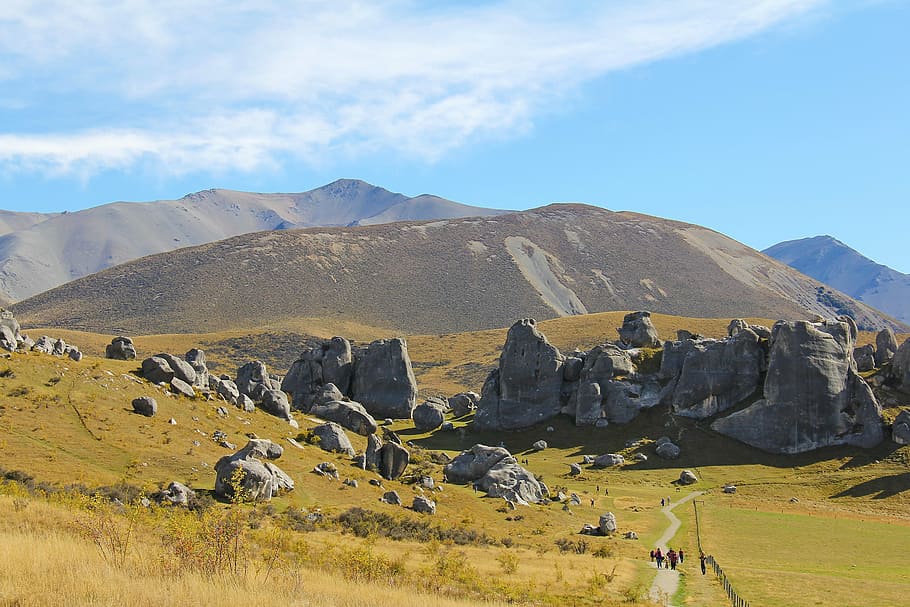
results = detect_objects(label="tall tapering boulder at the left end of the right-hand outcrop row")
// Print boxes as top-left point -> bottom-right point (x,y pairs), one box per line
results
474,318 -> 565,430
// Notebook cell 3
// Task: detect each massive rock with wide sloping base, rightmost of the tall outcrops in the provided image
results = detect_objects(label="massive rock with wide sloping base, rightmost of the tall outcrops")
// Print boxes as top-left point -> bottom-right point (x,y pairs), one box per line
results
711,317 -> 883,453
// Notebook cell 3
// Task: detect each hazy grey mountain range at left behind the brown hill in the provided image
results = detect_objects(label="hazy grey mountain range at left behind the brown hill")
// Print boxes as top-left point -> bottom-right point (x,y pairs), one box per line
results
0,179 -> 501,301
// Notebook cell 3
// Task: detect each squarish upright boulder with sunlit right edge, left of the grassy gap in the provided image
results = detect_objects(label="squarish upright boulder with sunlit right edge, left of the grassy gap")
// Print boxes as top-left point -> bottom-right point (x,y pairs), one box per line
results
351,338 -> 417,419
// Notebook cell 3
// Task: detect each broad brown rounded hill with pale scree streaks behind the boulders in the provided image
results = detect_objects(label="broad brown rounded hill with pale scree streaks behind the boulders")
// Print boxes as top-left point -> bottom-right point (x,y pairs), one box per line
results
14,204 -> 896,334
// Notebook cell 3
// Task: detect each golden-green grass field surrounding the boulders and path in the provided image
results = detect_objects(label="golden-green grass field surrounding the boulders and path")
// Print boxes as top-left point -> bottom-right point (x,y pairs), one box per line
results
0,313 -> 910,607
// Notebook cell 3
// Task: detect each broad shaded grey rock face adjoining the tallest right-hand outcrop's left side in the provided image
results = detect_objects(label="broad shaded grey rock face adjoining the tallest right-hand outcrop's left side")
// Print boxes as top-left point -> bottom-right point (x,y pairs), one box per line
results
661,327 -> 765,419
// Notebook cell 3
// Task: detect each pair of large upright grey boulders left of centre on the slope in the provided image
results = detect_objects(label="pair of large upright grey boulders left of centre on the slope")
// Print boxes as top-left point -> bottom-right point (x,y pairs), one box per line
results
281,337 -> 417,419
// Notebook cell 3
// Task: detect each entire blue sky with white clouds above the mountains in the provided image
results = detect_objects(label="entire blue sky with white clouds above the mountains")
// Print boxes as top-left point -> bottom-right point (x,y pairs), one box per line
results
0,0 -> 910,273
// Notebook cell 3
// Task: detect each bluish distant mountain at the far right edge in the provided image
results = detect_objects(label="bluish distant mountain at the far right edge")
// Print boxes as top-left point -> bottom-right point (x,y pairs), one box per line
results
764,236 -> 910,323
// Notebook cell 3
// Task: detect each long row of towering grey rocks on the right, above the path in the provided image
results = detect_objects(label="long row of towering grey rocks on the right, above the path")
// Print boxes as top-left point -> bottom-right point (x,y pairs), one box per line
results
474,312 -> 910,456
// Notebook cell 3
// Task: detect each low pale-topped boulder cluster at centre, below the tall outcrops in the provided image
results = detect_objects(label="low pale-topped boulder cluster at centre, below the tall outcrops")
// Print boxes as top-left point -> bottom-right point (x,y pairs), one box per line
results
444,444 -> 549,505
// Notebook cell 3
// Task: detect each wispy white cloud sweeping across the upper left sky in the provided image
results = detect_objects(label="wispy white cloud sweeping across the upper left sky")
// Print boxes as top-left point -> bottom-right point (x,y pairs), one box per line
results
0,0 -> 824,176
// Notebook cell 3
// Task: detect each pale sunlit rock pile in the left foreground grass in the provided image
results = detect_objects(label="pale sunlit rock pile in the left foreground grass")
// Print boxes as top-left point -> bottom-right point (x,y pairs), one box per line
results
215,439 -> 294,500
